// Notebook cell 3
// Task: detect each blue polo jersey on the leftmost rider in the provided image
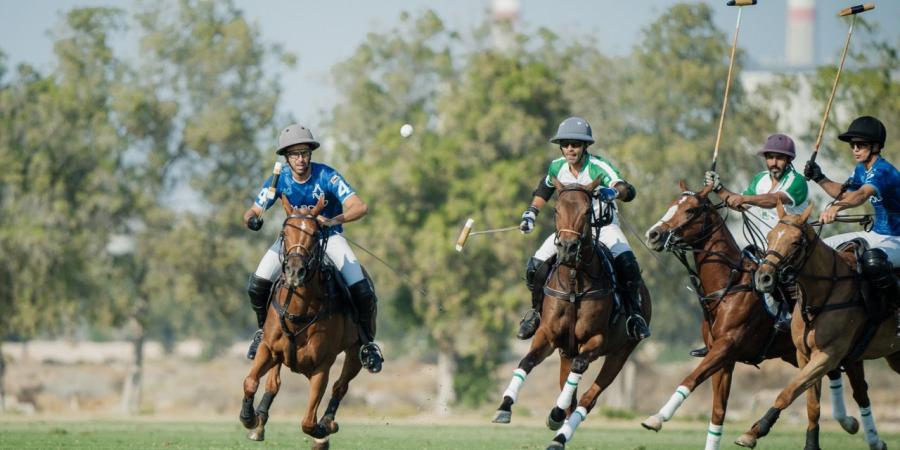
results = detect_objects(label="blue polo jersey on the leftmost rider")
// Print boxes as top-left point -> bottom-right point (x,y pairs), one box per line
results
256,163 -> 356,235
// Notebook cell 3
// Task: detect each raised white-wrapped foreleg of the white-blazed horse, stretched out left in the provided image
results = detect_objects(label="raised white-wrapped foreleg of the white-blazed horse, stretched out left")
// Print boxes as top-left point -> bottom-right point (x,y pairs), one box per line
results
641,336 -> 735,431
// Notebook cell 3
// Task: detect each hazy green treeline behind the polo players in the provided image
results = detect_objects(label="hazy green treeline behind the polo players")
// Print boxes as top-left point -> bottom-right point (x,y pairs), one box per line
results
0,1 -> 900,403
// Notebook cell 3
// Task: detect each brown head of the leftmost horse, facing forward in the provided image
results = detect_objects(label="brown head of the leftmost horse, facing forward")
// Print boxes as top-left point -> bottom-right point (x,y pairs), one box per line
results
281,196 -> 325,289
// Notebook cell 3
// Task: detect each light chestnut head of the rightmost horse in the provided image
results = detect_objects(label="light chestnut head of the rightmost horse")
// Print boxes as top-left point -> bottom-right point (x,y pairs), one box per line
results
754,199 -> 818,292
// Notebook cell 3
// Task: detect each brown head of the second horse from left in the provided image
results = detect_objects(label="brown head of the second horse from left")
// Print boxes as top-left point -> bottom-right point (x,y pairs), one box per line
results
553,177 -> 600,265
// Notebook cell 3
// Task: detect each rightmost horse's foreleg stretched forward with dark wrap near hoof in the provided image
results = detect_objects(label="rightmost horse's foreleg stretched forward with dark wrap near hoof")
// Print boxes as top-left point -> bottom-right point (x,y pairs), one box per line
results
734,350 -> 843,448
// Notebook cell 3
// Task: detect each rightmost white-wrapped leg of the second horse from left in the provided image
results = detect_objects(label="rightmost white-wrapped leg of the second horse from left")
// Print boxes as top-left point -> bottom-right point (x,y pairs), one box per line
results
547,344 -> 636,450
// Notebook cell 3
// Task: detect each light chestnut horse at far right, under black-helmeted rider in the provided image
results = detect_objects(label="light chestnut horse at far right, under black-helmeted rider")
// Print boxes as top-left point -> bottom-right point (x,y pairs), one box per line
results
735,202 -> 900,450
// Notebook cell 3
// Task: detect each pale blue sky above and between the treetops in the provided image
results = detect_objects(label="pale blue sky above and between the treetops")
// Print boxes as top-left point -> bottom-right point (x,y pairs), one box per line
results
0,0 -> 900,127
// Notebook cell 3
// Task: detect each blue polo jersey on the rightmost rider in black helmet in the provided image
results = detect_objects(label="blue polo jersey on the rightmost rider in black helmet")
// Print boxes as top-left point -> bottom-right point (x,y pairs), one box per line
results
847,157 -> 900,236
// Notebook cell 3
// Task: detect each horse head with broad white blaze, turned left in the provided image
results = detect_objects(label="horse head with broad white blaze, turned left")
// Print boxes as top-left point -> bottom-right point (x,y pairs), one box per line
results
646,180 -> 722,252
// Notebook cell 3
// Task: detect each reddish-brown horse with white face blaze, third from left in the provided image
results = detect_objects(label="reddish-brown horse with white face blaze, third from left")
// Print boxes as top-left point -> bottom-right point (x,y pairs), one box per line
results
641,181 -> 862,450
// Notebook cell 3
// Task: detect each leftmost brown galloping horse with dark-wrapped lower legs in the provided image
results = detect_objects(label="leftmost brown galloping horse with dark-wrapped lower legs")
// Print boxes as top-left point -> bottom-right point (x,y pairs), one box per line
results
240,197 -> 362,449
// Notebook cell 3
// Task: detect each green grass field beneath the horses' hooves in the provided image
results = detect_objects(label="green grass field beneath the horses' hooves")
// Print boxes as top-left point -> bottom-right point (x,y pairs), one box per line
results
0,417 -> 900,450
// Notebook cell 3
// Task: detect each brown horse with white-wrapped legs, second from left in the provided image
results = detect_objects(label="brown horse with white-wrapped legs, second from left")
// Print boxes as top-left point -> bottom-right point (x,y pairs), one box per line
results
494,179 -> 651,449
